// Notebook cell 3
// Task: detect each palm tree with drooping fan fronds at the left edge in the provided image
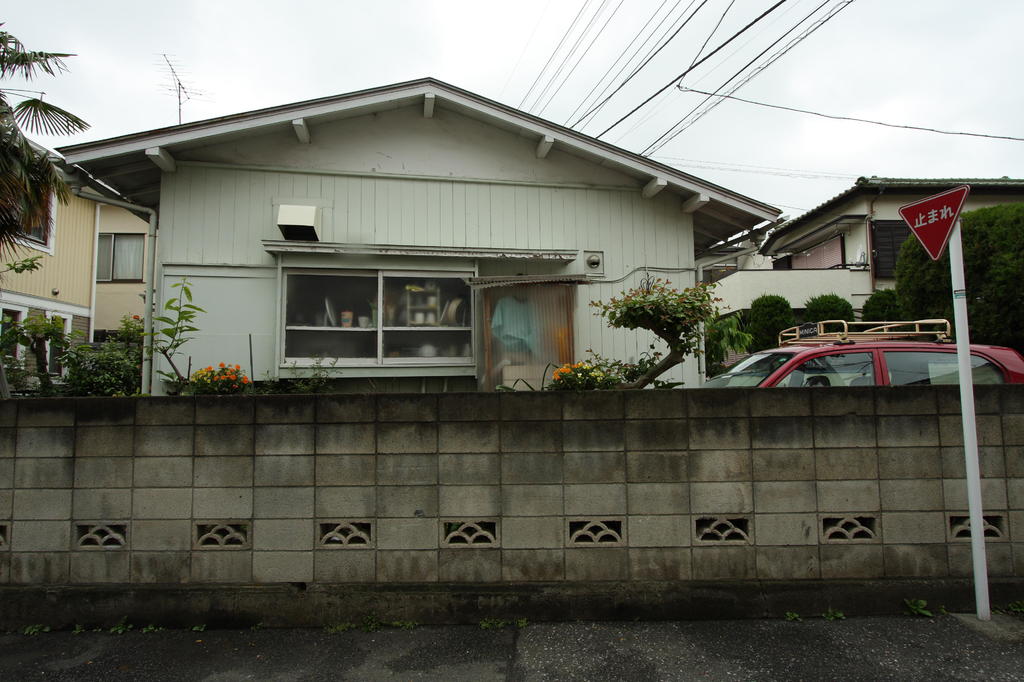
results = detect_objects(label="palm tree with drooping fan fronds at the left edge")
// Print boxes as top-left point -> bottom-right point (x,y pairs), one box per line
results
0,24 -> 89,255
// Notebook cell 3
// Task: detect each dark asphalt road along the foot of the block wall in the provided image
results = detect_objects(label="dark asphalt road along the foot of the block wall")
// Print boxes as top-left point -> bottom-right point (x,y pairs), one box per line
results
0,615 -> 1024,682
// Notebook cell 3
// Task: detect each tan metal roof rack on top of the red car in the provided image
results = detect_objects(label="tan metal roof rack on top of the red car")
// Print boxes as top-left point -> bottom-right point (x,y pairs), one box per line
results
778,319 -> 952,346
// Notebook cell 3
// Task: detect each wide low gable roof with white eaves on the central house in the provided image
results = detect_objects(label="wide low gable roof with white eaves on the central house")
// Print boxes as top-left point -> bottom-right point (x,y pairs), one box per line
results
59,78 -> 779,247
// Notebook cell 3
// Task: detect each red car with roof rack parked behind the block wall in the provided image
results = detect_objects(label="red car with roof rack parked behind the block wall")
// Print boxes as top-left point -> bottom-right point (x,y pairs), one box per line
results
703,319 -> 1024,388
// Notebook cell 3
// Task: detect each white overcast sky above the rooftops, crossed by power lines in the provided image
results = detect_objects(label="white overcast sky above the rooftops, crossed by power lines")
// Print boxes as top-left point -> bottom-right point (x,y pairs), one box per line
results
0,0 -> 1024,216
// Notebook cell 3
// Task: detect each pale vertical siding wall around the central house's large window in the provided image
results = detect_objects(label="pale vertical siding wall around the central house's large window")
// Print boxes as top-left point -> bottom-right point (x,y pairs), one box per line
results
159,163 -> 697,385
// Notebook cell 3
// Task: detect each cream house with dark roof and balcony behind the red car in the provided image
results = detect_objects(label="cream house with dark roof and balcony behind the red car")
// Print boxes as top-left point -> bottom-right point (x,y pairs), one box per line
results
715,177 -> 1024,310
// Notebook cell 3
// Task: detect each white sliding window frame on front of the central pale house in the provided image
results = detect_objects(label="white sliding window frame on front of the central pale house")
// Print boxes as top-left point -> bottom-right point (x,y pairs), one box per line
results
278,267 -> 478,376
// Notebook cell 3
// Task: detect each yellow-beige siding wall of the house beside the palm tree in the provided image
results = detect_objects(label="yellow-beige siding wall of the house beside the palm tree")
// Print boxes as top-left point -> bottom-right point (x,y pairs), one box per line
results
2,191 -> 95,308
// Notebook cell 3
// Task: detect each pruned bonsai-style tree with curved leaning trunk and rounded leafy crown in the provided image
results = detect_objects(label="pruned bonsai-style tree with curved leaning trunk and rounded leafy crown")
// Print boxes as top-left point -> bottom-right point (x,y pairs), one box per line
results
591,279 -> 720,388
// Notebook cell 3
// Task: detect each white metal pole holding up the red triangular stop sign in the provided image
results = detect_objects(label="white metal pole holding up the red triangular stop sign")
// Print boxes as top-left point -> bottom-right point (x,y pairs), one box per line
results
949,218 -> 992,621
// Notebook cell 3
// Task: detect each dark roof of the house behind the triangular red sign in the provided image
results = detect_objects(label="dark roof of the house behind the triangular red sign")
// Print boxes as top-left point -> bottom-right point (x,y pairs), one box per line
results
760,175 -> 1024,255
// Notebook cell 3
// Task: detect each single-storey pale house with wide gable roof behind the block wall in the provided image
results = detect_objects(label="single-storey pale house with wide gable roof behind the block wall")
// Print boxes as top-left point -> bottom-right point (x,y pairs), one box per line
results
61,79 -> 778,391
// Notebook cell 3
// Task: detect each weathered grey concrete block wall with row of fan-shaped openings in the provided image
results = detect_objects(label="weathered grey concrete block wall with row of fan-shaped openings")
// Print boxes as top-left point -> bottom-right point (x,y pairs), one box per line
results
0,386 -> 1024,586
